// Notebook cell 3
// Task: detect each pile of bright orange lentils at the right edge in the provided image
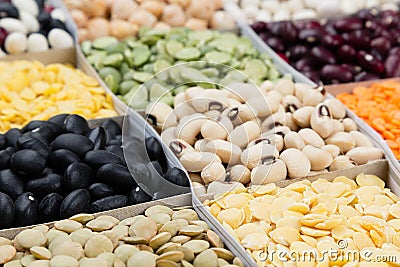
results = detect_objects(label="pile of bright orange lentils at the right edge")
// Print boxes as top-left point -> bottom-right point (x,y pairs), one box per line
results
337,81 -> 400,160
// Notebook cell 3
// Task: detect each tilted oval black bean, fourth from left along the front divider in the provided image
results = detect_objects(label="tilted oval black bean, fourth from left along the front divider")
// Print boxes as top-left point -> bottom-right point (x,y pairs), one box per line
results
60,189 -> 90,219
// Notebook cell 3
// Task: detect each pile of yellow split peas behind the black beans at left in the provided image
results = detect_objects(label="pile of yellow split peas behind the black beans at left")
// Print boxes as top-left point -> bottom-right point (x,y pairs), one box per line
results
0,61 -> 117,133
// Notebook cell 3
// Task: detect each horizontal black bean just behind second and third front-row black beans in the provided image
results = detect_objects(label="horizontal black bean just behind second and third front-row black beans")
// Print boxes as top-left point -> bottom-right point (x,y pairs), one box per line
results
25,174 -> 63,199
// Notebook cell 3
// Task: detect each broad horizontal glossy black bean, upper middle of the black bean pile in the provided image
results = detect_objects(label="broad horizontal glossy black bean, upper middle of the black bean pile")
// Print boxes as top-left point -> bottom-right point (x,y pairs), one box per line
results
51,133 -> 94,157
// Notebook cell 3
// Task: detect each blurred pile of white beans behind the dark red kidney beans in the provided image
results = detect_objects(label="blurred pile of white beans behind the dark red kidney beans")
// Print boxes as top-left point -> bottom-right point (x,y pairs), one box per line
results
234,0 -> 399,23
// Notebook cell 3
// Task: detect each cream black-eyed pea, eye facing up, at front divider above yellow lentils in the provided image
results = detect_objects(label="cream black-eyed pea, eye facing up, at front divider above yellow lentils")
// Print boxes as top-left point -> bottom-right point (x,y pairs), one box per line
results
250,159 -> 287,185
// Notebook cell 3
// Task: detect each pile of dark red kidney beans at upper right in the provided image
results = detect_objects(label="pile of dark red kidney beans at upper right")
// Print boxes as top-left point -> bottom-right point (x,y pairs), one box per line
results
252,9 -> 400,84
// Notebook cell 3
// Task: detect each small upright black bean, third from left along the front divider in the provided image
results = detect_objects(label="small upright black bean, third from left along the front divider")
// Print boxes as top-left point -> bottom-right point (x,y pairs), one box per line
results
38,193 -> 63,222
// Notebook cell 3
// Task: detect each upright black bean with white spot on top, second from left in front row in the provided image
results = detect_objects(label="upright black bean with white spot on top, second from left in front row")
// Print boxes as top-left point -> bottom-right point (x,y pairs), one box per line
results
14,192 -> 39,227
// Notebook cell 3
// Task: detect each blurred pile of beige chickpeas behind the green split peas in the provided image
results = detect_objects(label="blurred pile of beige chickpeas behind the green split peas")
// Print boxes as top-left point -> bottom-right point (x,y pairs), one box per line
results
64,0 -> 235,42
